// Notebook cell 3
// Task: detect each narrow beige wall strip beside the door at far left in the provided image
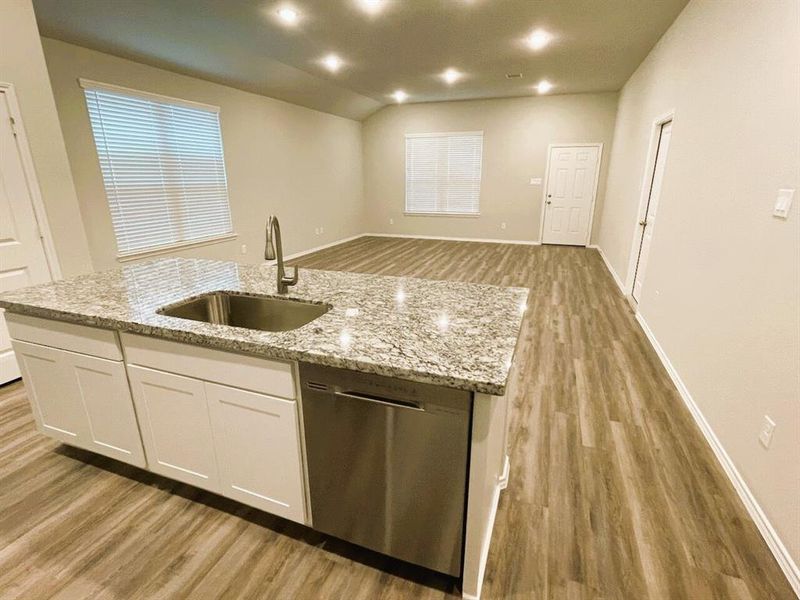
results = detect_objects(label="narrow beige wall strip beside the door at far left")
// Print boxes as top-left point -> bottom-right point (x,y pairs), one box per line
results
0,0 -> 91,277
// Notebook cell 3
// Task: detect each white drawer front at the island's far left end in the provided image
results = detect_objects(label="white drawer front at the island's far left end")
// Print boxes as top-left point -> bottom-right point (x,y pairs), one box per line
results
5,312 -> 122,360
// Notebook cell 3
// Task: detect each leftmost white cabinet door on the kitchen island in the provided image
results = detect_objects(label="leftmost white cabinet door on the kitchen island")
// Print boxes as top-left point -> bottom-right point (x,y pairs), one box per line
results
12,340 -> 88,446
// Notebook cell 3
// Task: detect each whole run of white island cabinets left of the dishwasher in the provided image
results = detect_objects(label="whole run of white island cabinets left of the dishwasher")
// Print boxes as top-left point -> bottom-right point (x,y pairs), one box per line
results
8,314 -> 307,523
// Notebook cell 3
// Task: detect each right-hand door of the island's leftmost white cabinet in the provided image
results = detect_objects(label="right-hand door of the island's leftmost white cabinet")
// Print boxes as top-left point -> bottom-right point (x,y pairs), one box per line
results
62,351 -> 146,467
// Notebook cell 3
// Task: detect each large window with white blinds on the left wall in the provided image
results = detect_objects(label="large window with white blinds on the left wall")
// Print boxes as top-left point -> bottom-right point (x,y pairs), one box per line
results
80,80 -> 233,257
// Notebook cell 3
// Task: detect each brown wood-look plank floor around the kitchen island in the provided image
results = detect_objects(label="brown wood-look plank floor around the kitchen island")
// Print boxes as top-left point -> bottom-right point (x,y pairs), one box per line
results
0,238 -> 794,600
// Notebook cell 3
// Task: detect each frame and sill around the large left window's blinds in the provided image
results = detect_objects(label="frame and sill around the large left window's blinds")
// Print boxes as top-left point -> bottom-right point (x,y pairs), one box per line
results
78,77 -> 238,262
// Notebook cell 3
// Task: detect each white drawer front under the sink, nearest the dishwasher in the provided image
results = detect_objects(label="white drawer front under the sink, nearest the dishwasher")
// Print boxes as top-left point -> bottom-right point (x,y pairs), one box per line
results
121,333 -> 297,400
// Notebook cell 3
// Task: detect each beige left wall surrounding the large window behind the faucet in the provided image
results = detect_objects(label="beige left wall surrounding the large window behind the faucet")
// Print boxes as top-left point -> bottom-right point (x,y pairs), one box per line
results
42,38 -> 364,269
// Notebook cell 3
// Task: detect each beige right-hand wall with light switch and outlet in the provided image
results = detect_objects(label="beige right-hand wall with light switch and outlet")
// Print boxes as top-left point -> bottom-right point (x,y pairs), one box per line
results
597,0 -> 800,563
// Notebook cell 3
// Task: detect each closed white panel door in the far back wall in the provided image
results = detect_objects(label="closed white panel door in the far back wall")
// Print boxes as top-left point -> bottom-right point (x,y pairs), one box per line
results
542,146 -> 600,246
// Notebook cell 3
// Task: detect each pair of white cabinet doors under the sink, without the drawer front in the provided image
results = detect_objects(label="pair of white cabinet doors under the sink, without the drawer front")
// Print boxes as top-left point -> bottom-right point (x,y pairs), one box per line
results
128,358 -> 306,523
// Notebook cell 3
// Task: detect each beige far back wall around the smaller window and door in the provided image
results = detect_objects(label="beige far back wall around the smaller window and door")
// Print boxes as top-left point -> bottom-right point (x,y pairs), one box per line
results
364,93 -> 617,241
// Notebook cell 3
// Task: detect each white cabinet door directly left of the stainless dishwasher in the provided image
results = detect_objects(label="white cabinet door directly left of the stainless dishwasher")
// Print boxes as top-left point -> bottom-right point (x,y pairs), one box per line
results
206,383 -> 305,523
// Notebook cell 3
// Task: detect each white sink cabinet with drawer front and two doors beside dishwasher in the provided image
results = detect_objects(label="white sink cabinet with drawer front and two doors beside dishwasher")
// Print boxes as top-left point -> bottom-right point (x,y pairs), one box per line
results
121,333 -> 307,523
